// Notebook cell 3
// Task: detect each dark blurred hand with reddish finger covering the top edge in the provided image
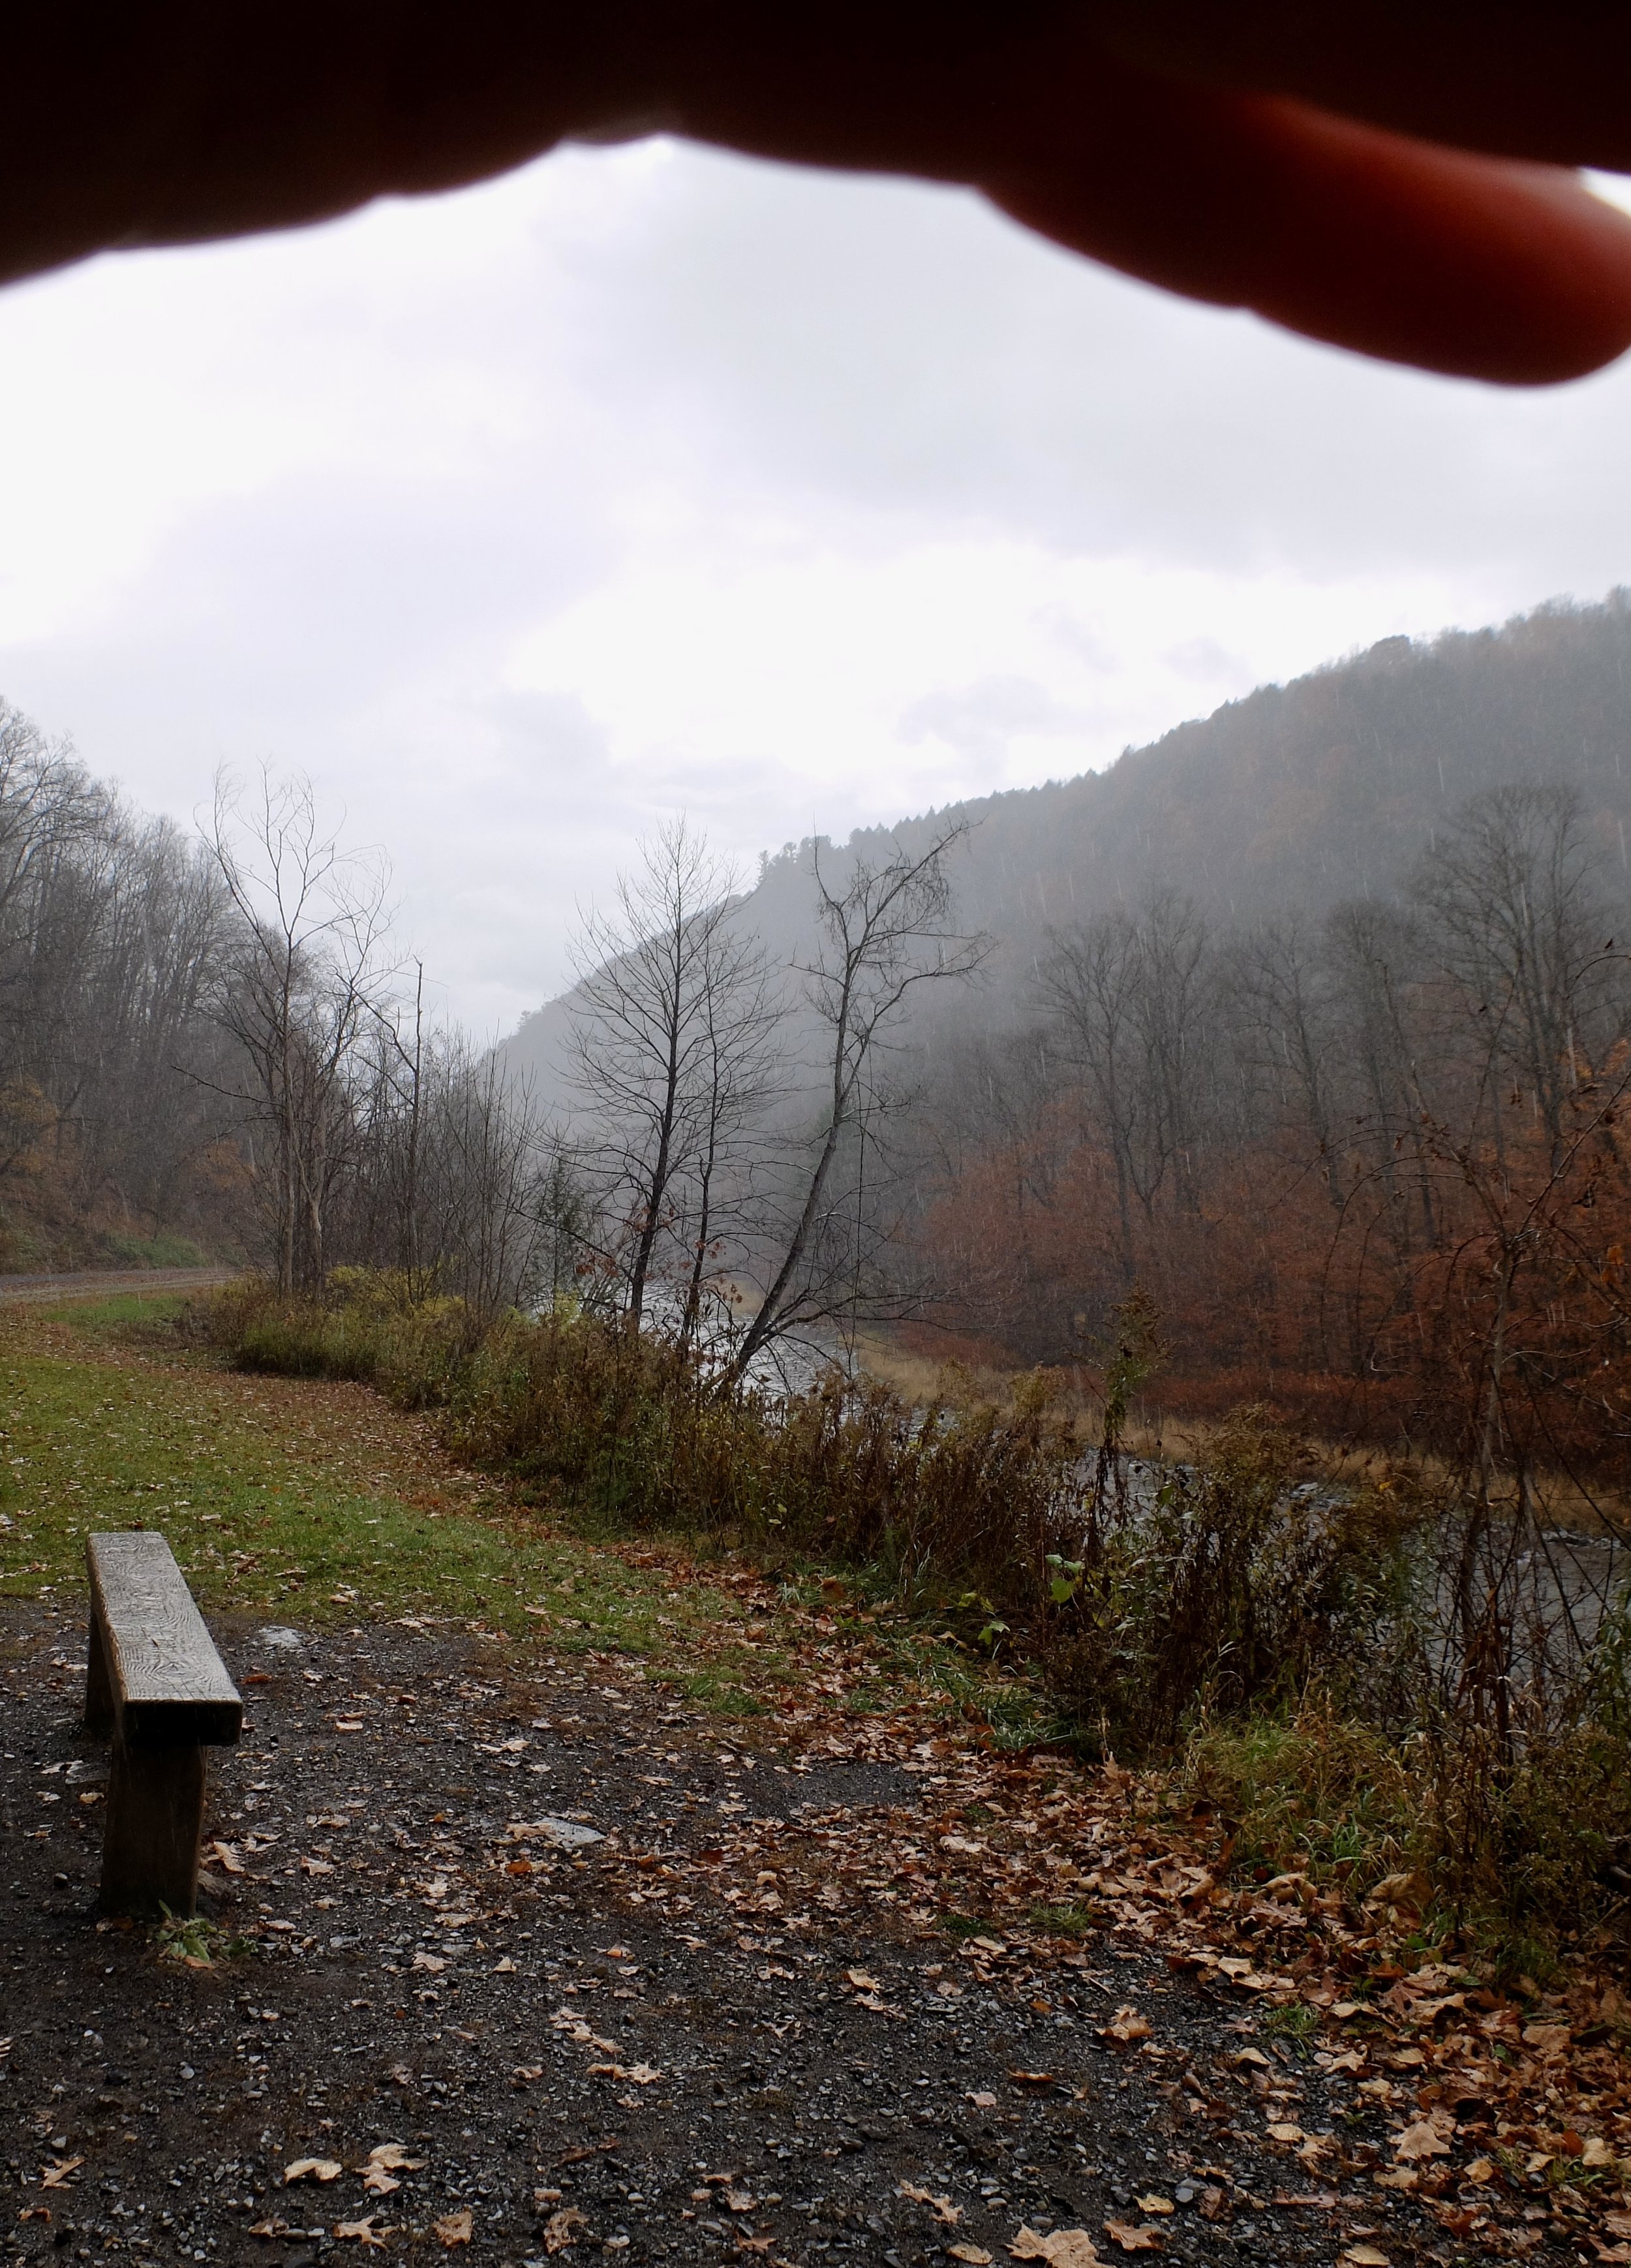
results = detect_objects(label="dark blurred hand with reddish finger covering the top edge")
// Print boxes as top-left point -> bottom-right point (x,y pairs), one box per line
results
0,0 -> 1631,383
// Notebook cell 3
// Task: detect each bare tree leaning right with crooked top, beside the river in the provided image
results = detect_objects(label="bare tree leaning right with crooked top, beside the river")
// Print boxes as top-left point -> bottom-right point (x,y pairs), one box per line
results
726,819 -> 991,1381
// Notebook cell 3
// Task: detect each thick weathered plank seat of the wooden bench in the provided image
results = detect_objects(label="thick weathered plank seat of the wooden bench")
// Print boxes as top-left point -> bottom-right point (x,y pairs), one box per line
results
86,1529 -> 243,1749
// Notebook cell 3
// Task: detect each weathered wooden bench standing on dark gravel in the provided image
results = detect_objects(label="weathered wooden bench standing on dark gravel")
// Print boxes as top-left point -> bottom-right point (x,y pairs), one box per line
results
84,1529 -> 243,1914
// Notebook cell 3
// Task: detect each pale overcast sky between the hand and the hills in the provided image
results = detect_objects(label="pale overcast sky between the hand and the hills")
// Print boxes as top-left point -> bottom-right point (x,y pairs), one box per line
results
0,143 -> 1631,1032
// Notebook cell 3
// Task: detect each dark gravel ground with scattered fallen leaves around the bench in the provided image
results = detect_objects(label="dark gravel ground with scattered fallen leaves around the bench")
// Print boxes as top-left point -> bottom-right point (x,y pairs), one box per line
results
0,1606 -> 1433,2268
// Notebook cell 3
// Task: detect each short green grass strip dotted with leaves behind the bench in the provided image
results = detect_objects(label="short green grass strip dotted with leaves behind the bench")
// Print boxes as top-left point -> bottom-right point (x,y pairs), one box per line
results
0,1295 -> 799,1712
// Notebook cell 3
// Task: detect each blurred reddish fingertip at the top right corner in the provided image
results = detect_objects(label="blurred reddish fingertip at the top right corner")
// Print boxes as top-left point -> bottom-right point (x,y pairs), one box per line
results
984,89 -> 1631,386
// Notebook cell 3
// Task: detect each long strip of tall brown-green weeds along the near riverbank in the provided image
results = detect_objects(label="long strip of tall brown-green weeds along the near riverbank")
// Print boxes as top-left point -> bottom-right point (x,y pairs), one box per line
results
209,1275 -> 1631,1971
